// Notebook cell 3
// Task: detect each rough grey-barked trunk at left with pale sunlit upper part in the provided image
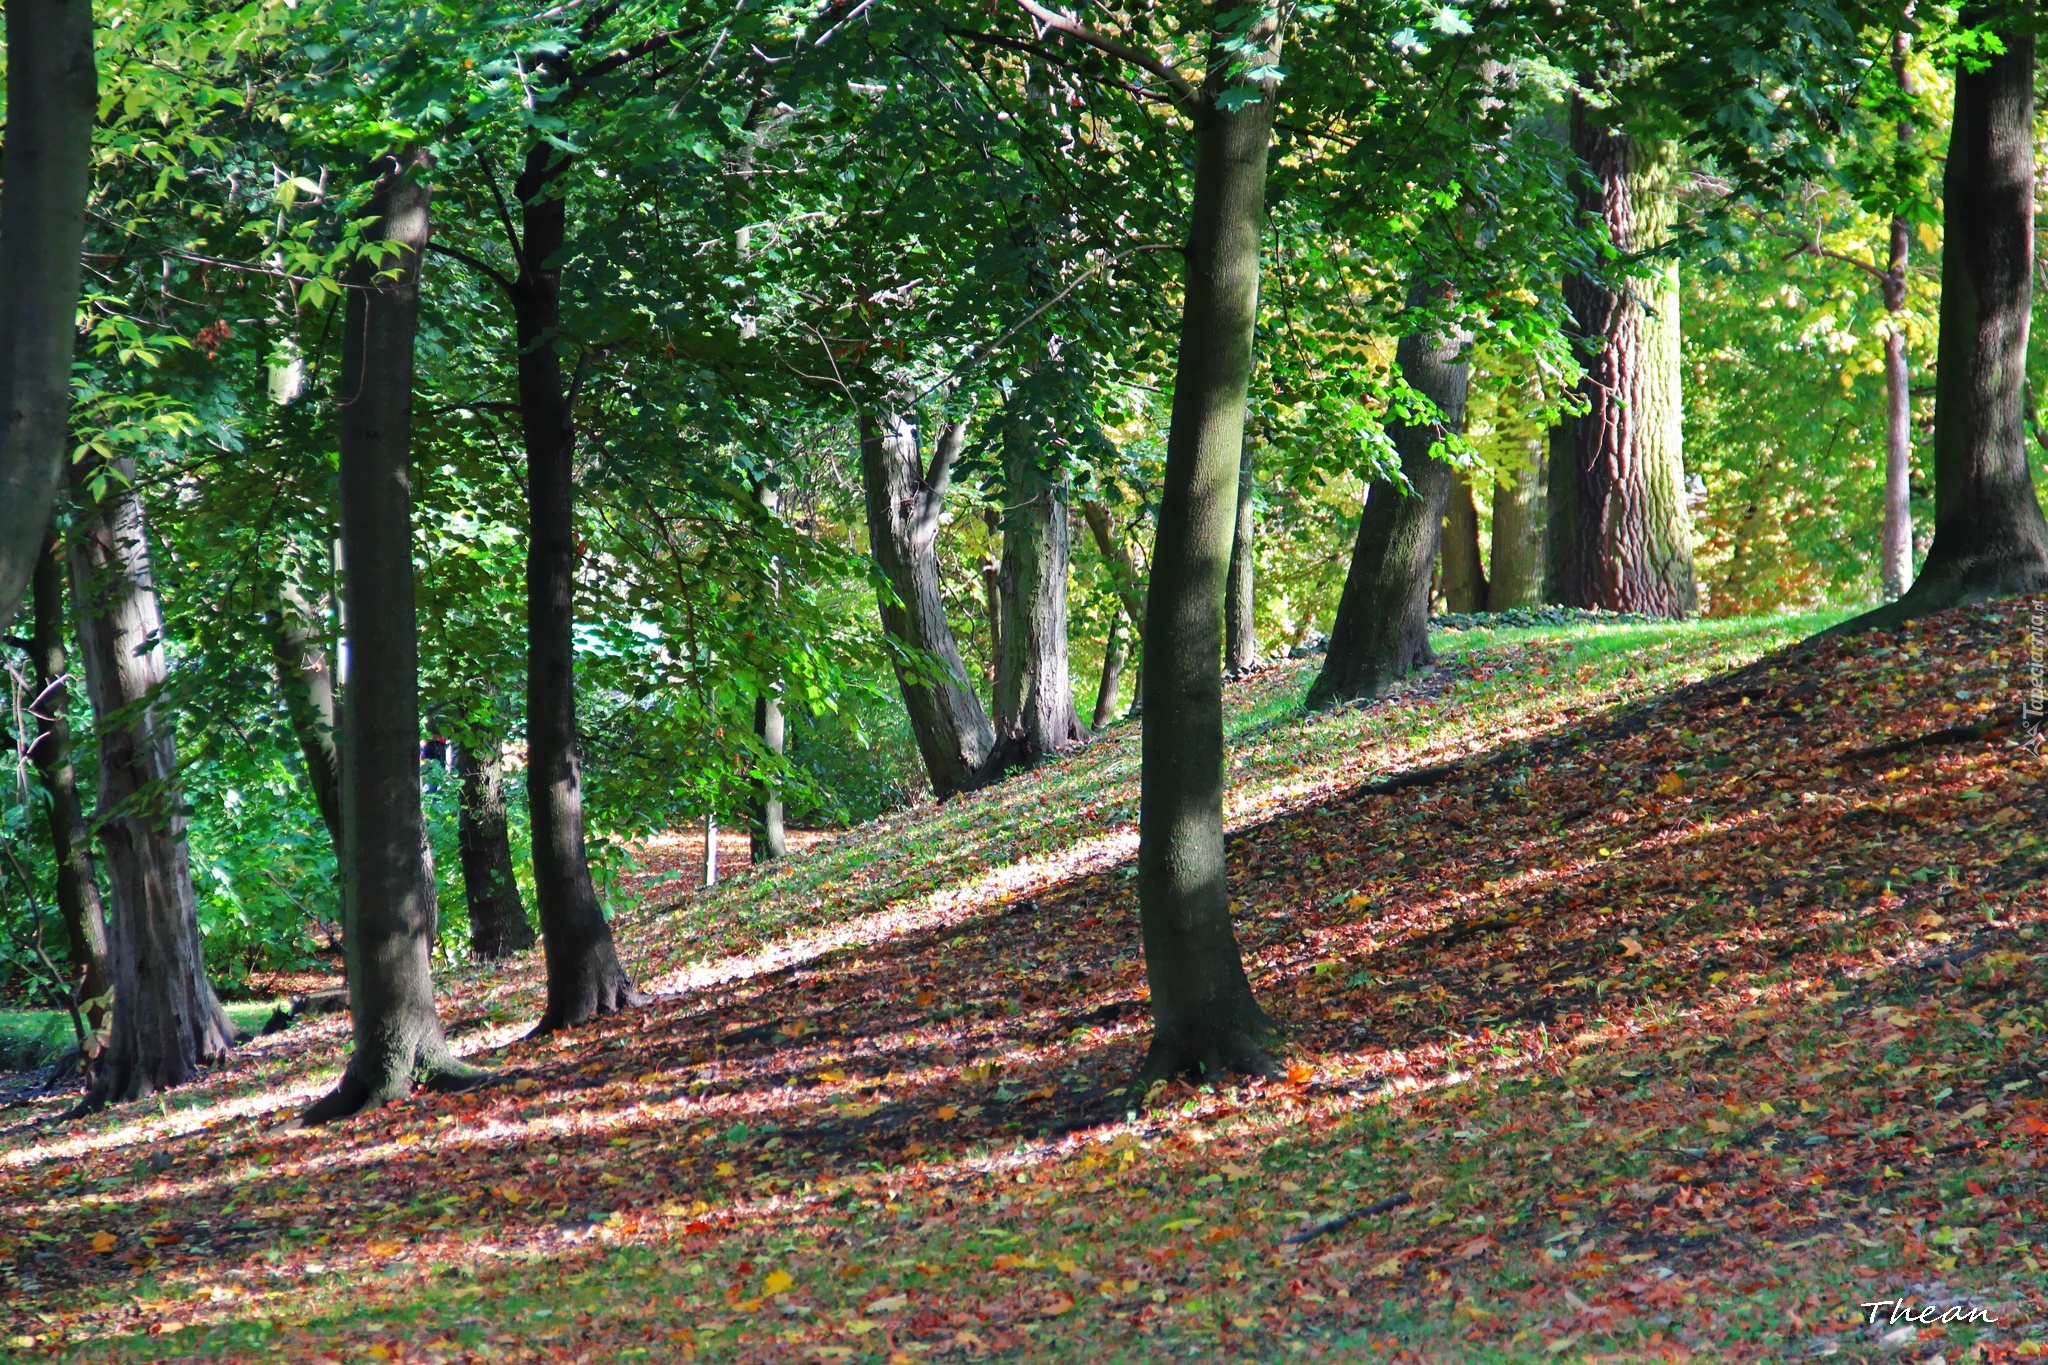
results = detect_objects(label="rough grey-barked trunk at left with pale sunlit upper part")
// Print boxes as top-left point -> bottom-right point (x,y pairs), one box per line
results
72,460 -> 236,1109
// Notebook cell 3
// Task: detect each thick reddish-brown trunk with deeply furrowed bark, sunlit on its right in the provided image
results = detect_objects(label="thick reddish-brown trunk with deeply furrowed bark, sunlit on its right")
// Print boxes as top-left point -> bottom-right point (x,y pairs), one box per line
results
1546,100 -> 1698,616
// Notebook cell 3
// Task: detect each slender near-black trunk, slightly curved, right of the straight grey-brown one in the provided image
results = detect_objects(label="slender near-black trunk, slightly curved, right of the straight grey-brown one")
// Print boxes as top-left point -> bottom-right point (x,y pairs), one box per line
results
512,143 -> 647,1033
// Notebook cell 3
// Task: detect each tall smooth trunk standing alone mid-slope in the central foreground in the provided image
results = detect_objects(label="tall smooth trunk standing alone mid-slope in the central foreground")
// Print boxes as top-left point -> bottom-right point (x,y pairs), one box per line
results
1139,63 -> 1276,1078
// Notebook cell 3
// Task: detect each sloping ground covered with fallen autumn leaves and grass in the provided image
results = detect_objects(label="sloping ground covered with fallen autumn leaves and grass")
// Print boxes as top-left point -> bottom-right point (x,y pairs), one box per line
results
0,600 -> 2048,1365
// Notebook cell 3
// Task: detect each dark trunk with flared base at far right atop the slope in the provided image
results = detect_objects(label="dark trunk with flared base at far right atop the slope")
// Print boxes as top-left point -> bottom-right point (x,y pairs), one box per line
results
1837,21 -> 2048,630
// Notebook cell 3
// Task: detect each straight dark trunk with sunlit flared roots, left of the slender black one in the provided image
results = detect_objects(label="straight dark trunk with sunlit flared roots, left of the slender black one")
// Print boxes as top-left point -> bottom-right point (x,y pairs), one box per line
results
305,153 -> 479,1124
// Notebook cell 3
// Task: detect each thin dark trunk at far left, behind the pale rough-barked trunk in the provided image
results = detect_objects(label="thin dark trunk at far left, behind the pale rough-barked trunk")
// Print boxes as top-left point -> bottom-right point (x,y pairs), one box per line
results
29,538 -> 111,1036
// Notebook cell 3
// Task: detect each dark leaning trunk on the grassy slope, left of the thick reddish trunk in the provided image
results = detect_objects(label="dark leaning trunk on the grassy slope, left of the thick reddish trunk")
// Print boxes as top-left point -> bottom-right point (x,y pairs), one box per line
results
1309,321 -> 1468,710
